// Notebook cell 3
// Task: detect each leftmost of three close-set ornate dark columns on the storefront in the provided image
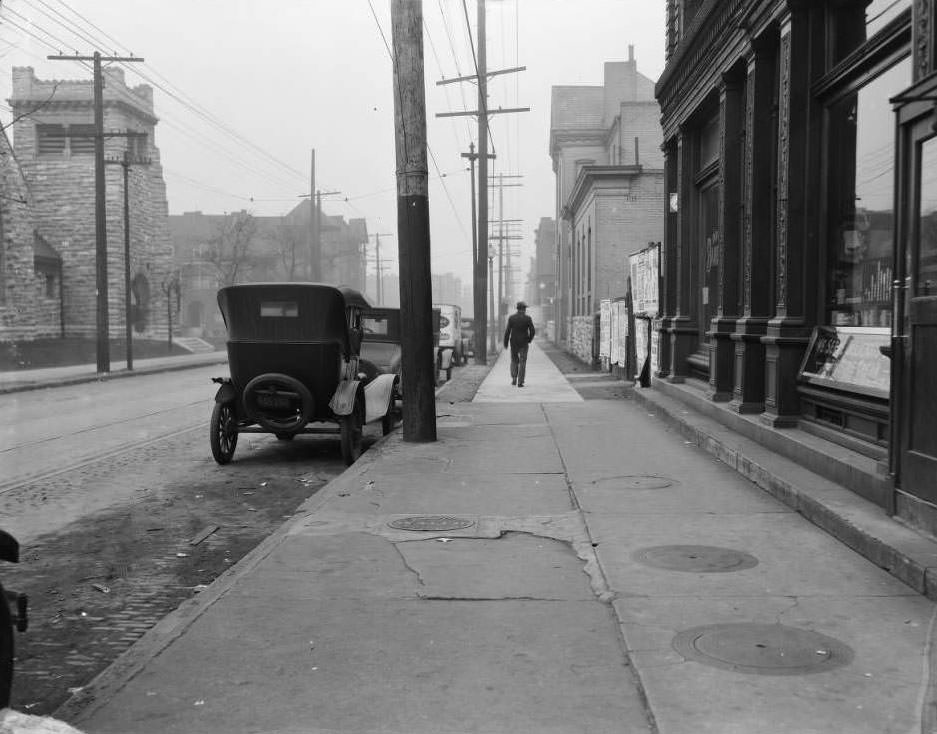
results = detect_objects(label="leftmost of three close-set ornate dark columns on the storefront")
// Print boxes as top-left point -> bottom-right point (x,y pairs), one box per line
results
708,70 -> 745,402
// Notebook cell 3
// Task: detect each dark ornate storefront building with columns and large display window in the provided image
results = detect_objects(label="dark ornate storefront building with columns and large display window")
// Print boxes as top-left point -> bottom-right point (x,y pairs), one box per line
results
655,0 -> 937,531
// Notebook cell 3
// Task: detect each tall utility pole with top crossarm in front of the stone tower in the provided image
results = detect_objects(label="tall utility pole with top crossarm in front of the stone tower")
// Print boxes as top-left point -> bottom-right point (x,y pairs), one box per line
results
47,51 -> 143,374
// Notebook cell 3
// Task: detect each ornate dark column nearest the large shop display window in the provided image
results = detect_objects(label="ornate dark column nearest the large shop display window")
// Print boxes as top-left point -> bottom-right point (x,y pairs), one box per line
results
761,0 -> 823,427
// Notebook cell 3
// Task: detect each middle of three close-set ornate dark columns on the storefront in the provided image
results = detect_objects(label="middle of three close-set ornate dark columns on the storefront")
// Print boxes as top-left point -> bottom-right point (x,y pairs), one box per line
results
730,32 -> 778,413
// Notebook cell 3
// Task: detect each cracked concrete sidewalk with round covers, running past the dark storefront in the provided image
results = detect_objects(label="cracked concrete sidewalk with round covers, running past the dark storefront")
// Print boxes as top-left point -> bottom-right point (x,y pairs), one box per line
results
51,343 -> 935,734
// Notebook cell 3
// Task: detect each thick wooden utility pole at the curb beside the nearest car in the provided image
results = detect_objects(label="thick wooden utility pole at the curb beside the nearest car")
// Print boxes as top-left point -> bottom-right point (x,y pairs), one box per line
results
390,0 -> 436,442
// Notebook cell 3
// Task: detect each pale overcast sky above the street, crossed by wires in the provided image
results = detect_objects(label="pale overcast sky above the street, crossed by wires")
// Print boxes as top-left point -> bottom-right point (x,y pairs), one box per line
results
0,0 -> 665,302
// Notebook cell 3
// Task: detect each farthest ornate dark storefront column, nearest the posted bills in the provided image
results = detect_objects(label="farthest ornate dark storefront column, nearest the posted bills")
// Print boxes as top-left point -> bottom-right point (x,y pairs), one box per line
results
667,127 -> 698,382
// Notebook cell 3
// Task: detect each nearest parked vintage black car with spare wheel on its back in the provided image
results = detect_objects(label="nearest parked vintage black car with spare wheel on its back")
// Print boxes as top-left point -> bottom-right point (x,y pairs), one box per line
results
210,283 -> 399,464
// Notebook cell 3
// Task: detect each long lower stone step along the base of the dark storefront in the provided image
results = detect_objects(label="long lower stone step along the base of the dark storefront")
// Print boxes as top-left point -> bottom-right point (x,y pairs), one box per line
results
634,387 -> 937,601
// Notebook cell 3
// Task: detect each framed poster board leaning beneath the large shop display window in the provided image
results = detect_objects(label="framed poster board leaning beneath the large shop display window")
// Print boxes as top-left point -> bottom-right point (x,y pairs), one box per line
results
797,326 -> 891,399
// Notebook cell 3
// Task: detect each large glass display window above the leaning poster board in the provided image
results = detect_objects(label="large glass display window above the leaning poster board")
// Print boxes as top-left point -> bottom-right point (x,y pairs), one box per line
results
826,59 -> 911,328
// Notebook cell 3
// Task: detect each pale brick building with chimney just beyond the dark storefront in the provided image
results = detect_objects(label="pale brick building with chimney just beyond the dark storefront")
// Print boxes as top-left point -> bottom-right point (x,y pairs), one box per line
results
550,46 -> 665,362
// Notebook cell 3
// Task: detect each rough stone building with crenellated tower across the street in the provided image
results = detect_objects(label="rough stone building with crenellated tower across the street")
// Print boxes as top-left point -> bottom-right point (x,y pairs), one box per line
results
5,67 -> 172,338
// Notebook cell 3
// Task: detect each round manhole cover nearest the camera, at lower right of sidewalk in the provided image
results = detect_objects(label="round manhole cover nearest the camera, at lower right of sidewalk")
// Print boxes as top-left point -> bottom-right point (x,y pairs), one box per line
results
673,623 -> 853,675
